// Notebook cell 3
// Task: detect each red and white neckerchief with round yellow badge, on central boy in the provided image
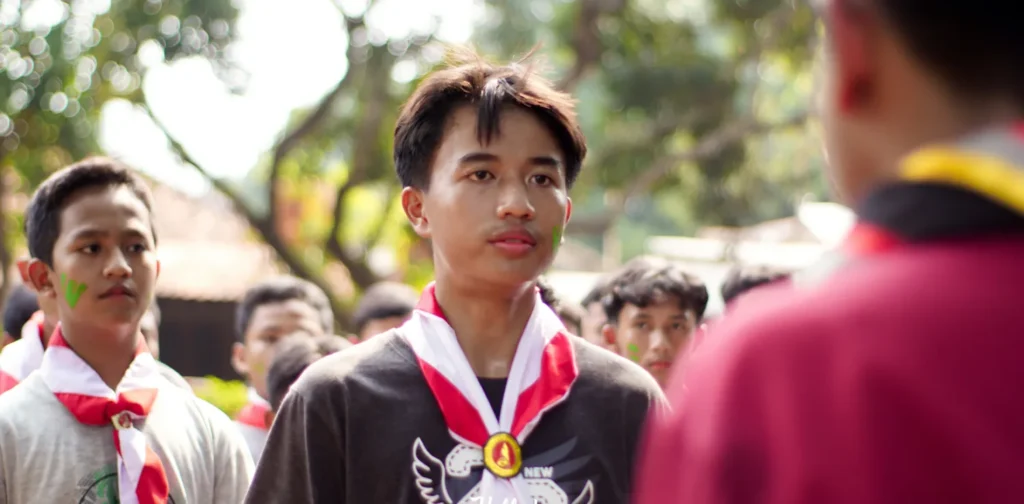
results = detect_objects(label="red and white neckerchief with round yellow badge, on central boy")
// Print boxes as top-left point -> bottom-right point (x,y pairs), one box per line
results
400,284 -> 579,502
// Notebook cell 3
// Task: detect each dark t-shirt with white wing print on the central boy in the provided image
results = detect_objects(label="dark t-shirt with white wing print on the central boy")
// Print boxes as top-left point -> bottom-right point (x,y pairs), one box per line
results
246,331 -> 665,504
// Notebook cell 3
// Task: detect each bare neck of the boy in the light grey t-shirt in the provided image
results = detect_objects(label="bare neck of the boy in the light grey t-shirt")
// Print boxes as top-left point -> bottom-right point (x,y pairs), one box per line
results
60,324 -> 142,390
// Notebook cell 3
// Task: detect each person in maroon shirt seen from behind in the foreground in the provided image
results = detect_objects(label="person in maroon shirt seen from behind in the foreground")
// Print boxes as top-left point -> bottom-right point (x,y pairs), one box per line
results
634,0 -> 1024,504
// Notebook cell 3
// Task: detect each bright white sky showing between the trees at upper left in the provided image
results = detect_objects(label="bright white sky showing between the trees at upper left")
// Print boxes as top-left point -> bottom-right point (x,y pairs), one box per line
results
100,0 -> 483,195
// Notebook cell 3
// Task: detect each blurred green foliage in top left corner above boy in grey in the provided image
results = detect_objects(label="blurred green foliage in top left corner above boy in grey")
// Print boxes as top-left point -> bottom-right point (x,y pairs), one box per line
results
0,0 -> 238,299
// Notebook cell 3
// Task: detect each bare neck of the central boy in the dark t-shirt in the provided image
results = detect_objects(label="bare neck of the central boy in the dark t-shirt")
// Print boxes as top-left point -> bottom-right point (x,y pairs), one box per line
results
434,278 -> 537,378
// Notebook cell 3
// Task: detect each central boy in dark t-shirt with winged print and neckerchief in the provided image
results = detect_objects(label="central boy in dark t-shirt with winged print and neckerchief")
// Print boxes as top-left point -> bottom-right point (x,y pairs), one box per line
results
247,53 -> 664,504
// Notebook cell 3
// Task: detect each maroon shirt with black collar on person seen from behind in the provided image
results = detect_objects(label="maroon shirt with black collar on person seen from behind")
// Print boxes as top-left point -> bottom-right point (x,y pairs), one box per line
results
635,184 -> 1024,504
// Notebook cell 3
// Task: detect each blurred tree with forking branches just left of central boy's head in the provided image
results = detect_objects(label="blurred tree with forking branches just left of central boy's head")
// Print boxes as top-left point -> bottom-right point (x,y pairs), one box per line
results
150,0 -> 443,327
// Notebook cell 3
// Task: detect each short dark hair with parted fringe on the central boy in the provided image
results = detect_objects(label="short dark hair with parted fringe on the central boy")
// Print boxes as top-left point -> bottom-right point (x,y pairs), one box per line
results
394,53 -> 587,191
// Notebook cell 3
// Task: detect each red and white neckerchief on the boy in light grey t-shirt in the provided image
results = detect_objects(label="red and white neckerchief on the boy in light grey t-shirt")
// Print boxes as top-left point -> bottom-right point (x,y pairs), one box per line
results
39,326 -> 169,504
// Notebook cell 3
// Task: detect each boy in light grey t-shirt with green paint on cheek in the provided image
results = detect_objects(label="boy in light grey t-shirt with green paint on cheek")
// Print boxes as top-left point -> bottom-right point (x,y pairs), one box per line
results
0,158 -> 253,504
